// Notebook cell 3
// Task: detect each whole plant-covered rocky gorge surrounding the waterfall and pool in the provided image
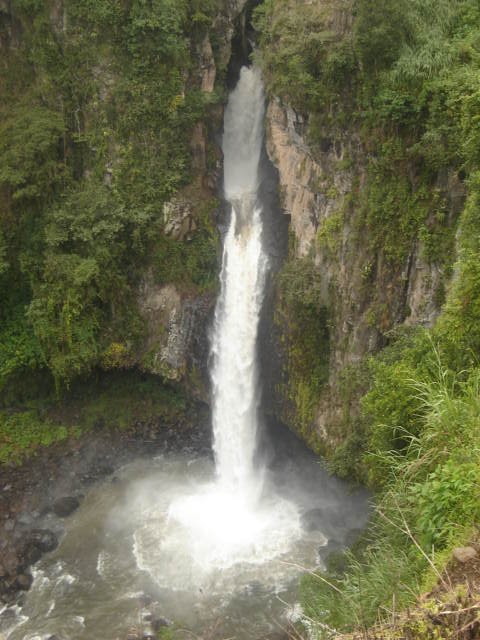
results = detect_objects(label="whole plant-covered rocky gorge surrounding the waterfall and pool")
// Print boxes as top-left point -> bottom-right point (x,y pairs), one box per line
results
0,0 -> 480,638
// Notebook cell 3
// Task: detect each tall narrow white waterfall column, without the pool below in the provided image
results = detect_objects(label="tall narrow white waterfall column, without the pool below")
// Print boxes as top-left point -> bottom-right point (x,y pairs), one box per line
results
212,67 -> 267,496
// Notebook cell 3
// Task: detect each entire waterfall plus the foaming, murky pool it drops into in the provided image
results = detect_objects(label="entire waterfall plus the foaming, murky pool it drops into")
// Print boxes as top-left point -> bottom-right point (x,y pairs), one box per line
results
0,68 -> 367,640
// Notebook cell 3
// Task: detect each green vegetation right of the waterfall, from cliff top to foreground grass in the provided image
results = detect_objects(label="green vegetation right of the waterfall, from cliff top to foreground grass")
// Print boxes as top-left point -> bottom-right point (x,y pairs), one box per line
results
256,0 -> 480,638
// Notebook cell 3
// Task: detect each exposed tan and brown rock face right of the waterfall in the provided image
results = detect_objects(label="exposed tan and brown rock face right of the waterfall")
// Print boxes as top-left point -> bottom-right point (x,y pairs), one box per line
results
267,98 -> 464,450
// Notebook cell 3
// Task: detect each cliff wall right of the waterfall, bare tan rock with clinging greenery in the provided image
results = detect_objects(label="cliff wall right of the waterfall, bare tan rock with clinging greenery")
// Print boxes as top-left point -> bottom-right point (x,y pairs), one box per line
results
257,0 -> 466,452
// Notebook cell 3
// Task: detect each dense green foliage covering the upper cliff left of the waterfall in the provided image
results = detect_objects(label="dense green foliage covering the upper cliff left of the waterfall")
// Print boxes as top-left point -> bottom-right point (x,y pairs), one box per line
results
0,0 -> 218,389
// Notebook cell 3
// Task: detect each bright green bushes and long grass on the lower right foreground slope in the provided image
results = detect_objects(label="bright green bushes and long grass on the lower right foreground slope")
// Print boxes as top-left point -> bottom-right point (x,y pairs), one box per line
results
302,333 -> 480,637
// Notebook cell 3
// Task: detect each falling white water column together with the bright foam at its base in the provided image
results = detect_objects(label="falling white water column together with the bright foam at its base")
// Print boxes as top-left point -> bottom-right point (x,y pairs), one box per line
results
154,67 -> 301,579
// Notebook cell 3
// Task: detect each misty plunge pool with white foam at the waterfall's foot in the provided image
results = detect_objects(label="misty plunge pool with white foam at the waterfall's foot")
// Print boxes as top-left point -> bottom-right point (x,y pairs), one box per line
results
0,425 -> 368,640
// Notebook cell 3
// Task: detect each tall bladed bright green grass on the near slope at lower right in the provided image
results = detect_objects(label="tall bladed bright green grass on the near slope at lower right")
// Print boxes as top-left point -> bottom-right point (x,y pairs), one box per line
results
302,350 -> 480,637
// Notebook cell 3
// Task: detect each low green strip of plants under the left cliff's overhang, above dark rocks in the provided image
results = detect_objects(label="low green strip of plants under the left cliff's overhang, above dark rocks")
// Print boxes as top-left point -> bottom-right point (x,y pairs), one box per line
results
0,371 -> 188,465
